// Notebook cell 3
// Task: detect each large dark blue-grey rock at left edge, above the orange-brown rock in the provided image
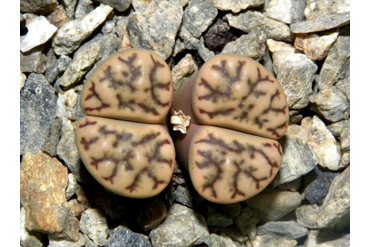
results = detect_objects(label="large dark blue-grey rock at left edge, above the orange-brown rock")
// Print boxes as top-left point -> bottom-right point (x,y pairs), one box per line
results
20,73 -> 56,155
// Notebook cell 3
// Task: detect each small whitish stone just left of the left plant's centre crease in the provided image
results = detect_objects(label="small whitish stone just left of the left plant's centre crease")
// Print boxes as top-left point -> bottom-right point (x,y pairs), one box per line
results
56,89 -> 77,120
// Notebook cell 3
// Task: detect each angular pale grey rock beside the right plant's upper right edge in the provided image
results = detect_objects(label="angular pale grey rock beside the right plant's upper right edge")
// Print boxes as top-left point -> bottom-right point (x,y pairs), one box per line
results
272,51 -> 318,109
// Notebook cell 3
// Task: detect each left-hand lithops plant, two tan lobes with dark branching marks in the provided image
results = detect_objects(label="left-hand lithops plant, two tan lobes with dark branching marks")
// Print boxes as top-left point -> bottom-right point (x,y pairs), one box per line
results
76,49 -> 175,198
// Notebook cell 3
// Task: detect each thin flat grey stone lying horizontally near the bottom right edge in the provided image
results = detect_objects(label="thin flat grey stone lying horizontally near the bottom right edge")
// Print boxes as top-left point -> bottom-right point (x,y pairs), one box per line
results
257,221 -> 308,239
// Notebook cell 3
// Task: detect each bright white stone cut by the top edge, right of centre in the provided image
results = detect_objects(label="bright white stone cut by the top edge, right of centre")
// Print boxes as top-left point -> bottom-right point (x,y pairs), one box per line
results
266,0 -> 306,24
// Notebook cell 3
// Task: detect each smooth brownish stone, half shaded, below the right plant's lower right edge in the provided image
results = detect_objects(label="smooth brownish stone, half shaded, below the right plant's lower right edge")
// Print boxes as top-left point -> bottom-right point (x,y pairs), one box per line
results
245,189 -> 302,224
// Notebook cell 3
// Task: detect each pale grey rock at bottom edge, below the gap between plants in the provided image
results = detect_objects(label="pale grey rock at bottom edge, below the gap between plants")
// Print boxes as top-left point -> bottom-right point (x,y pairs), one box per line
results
149,203 -> 209,247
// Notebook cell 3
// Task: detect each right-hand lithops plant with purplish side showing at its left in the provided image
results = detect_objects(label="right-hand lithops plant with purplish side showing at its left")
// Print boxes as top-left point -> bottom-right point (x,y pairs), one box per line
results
171,54 -> 289,203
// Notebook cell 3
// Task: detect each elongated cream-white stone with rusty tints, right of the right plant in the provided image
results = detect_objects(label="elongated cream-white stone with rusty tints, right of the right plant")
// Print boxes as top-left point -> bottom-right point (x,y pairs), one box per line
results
301,115 -> 342,171
